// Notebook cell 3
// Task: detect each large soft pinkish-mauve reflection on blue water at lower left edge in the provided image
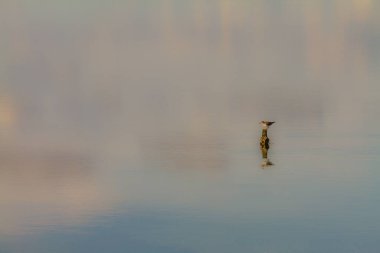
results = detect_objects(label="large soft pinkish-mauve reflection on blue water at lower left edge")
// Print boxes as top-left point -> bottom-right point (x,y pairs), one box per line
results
0,145 -> 122,235
